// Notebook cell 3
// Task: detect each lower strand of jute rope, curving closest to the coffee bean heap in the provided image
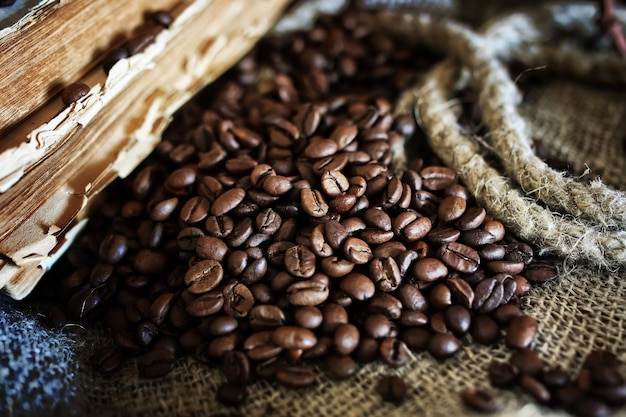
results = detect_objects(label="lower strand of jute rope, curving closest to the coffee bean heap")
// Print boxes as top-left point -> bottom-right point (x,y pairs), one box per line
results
397,60 -> 626,267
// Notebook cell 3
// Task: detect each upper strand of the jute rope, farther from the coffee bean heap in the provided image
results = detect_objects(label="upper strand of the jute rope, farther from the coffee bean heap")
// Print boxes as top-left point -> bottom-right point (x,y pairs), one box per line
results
364,6 -> 626,230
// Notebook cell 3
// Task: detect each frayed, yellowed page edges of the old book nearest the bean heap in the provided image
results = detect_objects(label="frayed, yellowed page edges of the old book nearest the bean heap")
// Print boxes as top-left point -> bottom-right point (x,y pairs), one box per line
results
0,0 -> 288,299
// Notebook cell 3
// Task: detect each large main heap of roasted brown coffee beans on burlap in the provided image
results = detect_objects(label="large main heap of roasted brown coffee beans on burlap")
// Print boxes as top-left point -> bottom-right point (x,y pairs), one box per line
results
34,4 -> 557,410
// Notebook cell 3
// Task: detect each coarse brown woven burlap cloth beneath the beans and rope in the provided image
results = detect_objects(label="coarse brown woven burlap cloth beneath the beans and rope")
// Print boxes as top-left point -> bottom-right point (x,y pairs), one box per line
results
4,2 -> 626,417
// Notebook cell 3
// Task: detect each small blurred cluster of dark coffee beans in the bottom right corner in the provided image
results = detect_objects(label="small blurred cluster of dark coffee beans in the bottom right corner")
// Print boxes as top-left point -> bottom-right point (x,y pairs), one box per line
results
462,349 -> 626,417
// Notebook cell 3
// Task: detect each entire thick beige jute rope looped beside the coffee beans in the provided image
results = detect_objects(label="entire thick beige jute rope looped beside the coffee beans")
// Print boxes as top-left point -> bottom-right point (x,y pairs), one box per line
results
360,5 -> 626,267
